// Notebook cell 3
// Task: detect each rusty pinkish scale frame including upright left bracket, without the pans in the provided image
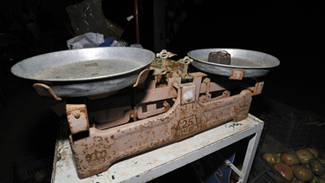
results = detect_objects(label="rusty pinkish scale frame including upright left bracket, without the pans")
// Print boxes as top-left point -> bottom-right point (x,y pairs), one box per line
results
66,72 -> 253,179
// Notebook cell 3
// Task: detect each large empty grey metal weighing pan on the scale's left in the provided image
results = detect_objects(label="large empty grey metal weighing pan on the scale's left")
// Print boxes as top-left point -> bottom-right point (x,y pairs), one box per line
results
11,47 -> 155,97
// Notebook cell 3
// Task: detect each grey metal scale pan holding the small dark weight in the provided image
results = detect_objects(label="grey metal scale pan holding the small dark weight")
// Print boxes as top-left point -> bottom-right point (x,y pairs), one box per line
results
187,48 -> 280,78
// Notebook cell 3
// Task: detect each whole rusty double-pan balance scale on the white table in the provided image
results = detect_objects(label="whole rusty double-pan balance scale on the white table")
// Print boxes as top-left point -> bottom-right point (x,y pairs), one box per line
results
11,47 -> 280,178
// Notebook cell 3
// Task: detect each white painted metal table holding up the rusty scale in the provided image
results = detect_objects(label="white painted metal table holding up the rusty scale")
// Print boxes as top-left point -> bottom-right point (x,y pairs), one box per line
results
52,114 -> 264,183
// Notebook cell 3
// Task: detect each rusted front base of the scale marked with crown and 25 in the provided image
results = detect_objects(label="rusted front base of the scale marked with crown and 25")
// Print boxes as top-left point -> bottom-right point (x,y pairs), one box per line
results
66,73 -> 253,178
